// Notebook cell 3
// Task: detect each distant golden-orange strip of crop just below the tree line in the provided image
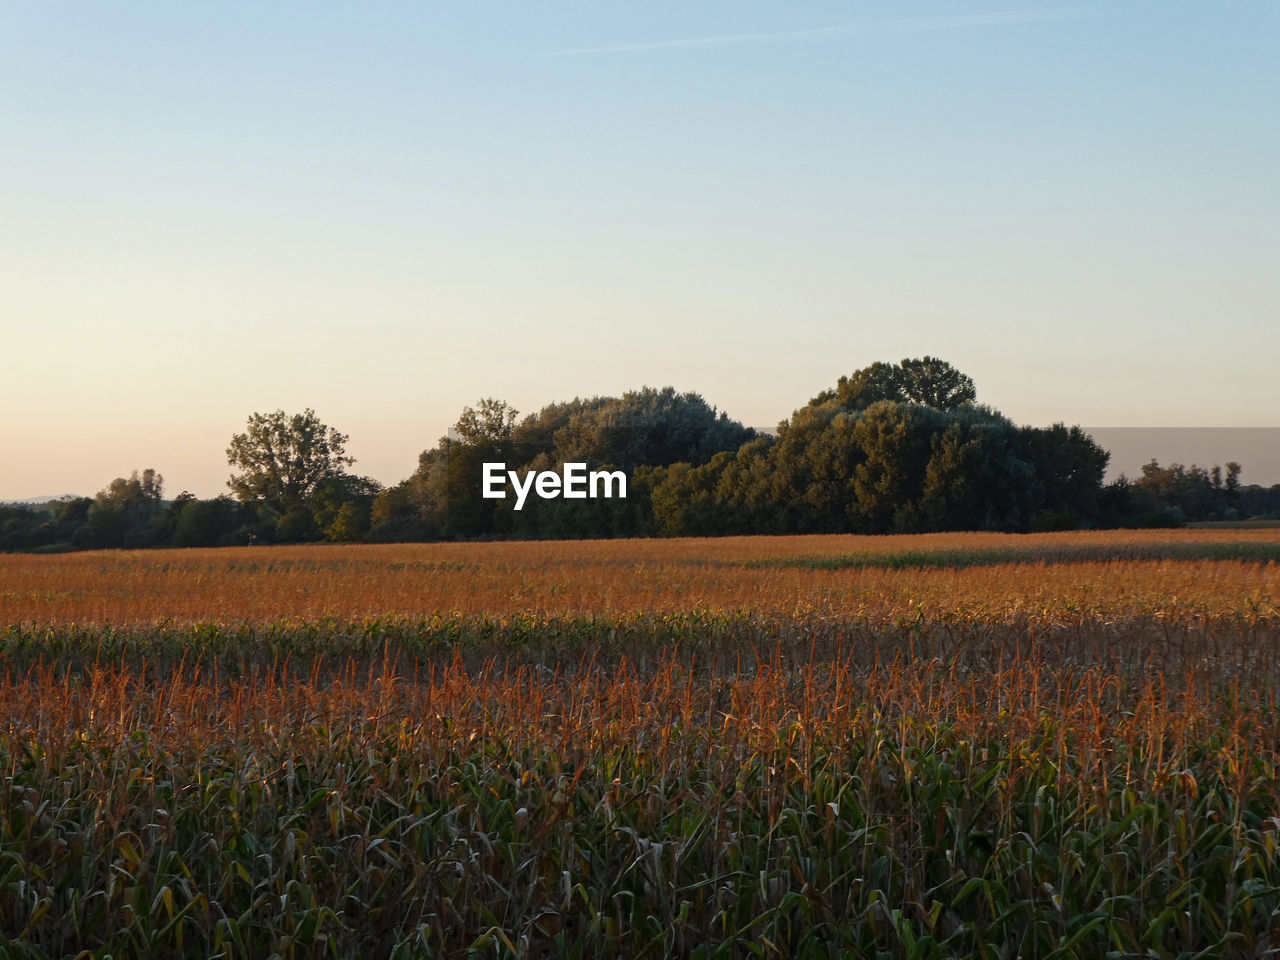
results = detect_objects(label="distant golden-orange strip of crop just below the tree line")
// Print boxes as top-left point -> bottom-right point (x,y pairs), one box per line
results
0,530 -> 1280,626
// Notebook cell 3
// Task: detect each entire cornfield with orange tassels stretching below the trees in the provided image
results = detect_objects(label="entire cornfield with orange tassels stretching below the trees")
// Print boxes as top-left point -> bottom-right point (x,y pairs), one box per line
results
0,529 -> 1280,960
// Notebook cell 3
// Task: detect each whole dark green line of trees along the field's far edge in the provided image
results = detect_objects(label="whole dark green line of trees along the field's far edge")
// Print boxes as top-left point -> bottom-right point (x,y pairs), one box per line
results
0,357 -> 1280,550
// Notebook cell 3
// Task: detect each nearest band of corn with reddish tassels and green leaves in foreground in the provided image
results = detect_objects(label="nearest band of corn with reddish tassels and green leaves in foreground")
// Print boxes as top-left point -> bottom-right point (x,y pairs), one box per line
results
0,634 -> 1280,957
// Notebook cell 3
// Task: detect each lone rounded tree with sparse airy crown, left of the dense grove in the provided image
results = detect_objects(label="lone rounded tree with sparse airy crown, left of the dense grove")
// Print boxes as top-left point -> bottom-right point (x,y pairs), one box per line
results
227,407 -> 356,515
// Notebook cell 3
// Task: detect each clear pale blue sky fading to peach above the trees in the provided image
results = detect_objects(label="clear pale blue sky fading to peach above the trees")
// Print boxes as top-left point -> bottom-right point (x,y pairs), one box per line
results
0,7 -> 1280,498
